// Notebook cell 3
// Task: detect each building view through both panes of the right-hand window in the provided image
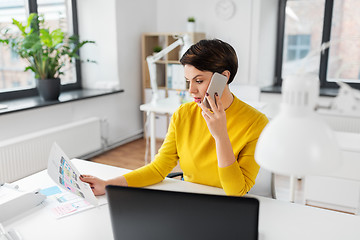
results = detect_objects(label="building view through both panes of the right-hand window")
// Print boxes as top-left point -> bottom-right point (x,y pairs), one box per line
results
282,0 -> 360,82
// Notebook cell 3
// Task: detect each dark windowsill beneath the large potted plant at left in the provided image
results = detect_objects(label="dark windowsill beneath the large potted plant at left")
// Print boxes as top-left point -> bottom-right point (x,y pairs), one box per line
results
0,89 -> 124,115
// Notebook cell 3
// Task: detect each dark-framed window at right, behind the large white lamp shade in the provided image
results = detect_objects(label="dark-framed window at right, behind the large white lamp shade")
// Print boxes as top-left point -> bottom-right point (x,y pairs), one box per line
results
275,0 -> 360,89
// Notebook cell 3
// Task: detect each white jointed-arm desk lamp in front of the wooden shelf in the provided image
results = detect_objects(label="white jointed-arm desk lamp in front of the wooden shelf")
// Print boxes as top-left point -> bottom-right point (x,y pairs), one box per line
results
146,34 -> 193,104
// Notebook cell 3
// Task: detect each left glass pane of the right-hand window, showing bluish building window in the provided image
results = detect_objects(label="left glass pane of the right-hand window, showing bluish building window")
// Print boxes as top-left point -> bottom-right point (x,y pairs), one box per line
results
282,0 -> 325,78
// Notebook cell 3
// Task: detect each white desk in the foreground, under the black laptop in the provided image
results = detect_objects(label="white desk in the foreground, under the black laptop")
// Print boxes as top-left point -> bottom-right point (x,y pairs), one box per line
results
4,160 -> 360,240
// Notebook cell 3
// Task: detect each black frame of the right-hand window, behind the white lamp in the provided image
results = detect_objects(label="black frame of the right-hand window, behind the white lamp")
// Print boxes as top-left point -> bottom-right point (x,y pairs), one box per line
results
273,0 -> 360,89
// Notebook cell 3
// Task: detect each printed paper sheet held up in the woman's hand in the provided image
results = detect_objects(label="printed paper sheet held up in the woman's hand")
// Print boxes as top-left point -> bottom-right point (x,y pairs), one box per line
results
47,143 -> 98,206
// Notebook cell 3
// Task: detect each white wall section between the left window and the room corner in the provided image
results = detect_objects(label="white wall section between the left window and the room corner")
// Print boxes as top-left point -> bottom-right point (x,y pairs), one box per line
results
77,0 -> 119,88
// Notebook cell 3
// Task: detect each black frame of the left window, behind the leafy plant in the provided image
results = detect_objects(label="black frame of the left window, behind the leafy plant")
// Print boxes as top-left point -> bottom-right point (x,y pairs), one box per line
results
0,0 -> 82,101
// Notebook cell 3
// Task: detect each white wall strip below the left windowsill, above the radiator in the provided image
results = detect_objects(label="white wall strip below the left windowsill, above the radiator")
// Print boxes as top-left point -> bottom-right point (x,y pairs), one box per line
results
0,93 -> 142,143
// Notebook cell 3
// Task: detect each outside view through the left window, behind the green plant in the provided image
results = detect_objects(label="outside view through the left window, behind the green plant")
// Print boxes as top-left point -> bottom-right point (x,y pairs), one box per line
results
0,0 -> 76,92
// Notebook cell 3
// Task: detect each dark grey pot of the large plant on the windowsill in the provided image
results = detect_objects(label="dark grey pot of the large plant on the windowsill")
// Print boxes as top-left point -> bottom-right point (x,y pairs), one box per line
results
36,78 -> 61,101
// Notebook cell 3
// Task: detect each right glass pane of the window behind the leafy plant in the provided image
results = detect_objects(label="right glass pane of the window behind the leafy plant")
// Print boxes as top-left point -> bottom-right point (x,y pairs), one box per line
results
37,0 -> 76,84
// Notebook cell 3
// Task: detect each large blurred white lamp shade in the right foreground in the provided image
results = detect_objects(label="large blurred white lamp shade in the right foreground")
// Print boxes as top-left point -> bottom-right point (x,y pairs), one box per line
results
255,75 -> 341,176
